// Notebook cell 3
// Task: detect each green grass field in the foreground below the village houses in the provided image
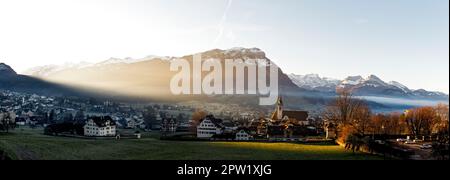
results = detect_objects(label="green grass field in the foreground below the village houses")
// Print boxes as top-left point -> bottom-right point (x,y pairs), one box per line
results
0,129 -> 382,160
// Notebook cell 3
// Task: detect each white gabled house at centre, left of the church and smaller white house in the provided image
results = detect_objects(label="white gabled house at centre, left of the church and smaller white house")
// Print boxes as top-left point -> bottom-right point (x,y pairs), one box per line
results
197,116 -> 223,139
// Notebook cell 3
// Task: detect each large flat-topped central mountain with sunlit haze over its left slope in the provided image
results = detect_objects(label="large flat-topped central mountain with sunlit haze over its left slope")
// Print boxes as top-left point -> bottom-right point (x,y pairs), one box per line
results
19,48 -> 312,105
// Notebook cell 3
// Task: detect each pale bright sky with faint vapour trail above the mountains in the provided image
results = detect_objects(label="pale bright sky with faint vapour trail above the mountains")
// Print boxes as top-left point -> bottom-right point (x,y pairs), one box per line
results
0,0 -> 449,93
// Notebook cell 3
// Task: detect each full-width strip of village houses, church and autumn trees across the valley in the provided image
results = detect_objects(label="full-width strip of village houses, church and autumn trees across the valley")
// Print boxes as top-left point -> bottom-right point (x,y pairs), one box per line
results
0,91 -> 448,159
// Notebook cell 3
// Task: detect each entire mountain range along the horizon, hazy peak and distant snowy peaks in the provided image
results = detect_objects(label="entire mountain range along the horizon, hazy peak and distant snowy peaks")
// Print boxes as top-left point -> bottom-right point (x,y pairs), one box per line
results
0,48 -> 448,111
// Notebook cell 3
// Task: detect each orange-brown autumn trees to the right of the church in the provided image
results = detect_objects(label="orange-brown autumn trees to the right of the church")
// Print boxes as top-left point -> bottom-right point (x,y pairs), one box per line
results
323,91 -> 449,158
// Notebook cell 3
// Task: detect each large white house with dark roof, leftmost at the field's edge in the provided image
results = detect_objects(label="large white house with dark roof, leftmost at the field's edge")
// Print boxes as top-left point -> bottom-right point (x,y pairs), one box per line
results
84,116 -> 116,137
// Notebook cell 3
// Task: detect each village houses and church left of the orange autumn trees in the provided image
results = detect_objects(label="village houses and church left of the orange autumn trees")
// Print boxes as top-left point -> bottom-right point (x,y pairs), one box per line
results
0,92 -> 323,141
